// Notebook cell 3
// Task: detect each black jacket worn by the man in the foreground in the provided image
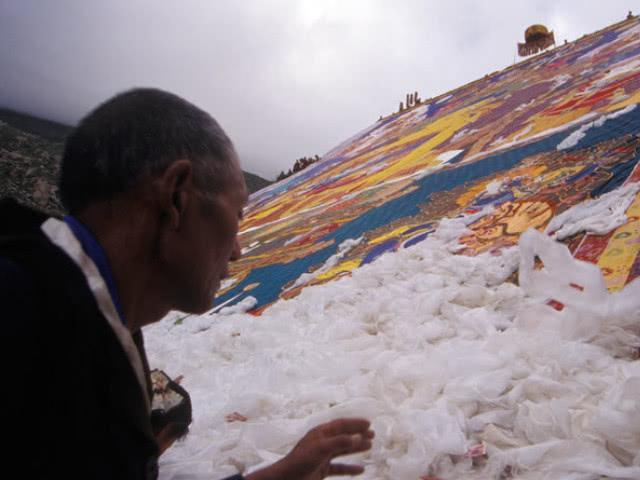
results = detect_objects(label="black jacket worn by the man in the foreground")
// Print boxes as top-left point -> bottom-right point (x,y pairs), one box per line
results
0,200 -> 158,479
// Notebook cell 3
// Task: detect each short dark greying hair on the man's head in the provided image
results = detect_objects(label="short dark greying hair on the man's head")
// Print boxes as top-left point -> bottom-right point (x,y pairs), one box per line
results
59,88 -> 237,213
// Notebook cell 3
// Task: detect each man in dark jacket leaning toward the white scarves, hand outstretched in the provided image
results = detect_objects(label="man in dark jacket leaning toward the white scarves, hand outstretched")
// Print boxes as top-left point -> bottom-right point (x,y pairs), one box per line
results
0,89 -> 373,480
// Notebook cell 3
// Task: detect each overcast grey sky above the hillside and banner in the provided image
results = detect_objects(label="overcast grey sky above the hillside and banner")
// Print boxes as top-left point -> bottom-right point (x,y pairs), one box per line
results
0,0 -> 640,179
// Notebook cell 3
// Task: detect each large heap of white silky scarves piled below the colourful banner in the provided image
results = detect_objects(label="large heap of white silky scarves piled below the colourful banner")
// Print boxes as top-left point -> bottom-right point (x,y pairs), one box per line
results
146,185 -> 640,480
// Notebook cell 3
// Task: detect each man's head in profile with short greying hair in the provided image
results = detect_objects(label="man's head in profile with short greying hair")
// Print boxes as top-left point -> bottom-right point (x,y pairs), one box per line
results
59,89 -> 247,312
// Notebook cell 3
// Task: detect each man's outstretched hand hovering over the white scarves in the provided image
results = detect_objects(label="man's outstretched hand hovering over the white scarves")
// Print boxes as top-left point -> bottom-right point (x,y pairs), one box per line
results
246,418 -> 374,480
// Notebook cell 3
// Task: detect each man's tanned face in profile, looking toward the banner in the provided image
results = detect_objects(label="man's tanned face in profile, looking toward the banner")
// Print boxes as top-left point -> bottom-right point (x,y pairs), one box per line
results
170,159 -> 247,313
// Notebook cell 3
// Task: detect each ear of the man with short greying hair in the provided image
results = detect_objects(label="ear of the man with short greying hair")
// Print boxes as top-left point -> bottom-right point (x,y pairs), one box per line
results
160,159 -> 193,230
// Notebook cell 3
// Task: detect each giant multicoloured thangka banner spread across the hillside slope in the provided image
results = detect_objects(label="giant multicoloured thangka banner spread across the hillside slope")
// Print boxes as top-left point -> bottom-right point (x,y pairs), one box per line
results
216,17 -> 640,314
